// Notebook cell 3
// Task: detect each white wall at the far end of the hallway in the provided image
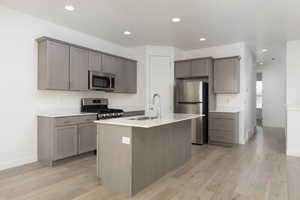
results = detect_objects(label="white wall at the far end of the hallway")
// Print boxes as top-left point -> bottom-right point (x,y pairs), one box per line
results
257,63 -> 286,128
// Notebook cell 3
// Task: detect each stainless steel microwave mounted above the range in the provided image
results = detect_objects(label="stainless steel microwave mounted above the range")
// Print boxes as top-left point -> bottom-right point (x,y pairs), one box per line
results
89,71 -> 115,91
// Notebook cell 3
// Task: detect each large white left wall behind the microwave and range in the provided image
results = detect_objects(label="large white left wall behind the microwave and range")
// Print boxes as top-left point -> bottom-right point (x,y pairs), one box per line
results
0,7 -> 145,169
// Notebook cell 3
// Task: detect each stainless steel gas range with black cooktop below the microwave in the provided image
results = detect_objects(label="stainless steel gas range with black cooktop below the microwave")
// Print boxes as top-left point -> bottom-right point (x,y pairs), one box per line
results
81,98 -> 124,120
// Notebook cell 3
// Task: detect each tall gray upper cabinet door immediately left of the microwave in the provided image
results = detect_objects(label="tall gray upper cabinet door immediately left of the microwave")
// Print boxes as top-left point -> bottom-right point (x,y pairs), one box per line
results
70,47 -> 89,91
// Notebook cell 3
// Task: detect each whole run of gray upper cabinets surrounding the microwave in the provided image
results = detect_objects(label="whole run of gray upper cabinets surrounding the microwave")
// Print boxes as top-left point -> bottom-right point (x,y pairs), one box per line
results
37,37 -> 137,93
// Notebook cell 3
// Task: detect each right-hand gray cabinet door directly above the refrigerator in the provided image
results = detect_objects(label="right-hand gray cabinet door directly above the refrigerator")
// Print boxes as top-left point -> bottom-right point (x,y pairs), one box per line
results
191,59 -> 211,77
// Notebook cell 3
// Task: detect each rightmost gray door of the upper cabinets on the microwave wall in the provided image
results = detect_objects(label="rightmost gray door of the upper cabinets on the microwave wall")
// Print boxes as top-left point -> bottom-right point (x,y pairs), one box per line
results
121,60 -> 137,93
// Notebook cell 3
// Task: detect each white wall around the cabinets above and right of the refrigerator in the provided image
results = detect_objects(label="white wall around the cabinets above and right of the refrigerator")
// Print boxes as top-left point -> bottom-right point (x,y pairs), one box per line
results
176,42 -> 256,144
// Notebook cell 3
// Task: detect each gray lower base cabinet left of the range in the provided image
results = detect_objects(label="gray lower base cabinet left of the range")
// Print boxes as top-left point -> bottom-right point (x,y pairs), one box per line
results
38,114 -> 97,166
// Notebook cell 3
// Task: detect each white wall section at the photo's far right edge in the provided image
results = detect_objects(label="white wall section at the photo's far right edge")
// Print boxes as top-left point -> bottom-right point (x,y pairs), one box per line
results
286,40 -> 300,157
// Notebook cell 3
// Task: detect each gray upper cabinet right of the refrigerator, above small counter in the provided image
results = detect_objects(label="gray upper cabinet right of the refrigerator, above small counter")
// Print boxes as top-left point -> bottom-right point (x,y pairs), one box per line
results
214,57 -> 240,94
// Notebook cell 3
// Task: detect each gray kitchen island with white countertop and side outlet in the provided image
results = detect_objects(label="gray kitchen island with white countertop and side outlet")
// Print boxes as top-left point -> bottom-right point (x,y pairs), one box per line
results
95,114 -> 203,196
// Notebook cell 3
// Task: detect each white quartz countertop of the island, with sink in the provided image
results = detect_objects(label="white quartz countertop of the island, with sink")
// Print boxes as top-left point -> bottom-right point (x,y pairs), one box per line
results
95,114 -> 204,128
